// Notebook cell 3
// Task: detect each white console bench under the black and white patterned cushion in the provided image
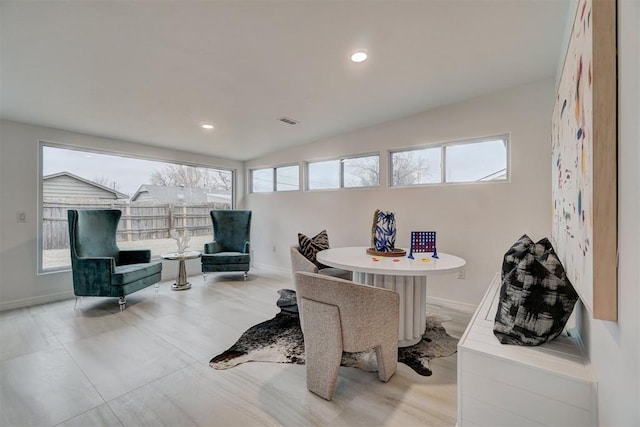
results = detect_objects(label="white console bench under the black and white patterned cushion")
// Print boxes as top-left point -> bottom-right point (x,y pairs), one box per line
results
458,274 -> 598,427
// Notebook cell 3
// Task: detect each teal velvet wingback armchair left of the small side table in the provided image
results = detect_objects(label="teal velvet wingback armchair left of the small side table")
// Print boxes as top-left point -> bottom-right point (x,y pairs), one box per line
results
67,209 -> 162,310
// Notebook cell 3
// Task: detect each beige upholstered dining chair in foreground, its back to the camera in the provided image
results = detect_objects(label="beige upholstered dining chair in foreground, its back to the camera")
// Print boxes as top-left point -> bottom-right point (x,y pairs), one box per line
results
295,272 -> 400,400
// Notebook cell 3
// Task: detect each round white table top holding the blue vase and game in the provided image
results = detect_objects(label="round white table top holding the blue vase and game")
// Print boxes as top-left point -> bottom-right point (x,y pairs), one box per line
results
316,246 -> 467,276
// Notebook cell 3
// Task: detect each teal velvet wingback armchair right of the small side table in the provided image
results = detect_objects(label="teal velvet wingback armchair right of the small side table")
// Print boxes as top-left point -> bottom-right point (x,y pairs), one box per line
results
201,210 -> 251,280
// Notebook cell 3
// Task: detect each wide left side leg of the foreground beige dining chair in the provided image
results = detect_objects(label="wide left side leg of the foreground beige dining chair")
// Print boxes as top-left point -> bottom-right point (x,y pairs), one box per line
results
302,299 -> 343,400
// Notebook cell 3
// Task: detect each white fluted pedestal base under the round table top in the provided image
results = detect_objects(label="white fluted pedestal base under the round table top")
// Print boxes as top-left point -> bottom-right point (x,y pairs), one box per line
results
353,271 -> 427,347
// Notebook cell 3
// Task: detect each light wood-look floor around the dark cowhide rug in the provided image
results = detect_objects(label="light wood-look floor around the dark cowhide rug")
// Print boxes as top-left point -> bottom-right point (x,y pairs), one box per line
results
0,270 -> 470,427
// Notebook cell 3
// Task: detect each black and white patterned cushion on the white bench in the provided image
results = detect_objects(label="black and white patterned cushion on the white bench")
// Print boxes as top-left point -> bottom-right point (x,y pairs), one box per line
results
493,236 -> 578,346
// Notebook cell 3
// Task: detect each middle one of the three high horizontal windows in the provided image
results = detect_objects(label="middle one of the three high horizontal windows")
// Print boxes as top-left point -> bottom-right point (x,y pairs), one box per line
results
307,154 -> 380,190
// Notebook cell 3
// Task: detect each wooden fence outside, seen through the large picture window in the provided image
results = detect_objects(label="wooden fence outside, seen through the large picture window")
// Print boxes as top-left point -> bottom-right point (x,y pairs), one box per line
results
42,200 -> 231,250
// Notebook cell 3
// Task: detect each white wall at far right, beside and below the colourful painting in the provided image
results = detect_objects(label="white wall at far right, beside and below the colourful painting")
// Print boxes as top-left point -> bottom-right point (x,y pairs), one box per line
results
578,0 -> 640,427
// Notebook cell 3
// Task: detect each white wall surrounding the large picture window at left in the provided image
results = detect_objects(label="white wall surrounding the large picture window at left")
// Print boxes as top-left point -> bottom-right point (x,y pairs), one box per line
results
0,120 -> 244,310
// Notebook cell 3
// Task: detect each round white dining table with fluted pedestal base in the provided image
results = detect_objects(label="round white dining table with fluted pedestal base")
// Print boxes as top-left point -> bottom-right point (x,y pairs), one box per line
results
316,246 -> 466,347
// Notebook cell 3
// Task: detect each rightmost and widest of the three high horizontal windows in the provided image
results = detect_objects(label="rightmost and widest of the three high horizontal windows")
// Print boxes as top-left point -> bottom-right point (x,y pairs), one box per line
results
390,136 -> 509,187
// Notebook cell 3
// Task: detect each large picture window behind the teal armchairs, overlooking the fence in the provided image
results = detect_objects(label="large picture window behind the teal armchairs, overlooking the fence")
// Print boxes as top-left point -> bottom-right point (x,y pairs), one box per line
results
39,144 -> 233,271
